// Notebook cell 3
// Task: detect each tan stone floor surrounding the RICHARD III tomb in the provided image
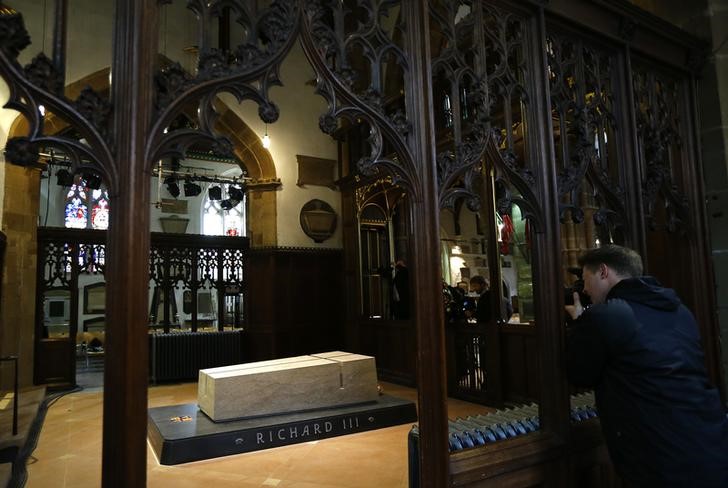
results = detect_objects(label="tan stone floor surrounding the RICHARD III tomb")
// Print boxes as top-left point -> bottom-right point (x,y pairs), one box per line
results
26,383 -> 488,488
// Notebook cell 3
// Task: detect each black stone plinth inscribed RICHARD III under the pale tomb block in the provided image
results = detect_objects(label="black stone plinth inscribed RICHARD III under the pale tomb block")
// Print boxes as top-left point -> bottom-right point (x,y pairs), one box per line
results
148,395 -> 417,465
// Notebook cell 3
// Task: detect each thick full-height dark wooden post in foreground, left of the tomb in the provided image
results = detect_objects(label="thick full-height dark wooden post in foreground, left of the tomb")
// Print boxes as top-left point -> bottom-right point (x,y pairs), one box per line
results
102,0 -> 159,488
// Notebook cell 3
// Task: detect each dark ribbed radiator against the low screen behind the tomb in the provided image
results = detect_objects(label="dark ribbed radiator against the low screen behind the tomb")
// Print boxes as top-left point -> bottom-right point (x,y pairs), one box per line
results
149,329 -> 243,383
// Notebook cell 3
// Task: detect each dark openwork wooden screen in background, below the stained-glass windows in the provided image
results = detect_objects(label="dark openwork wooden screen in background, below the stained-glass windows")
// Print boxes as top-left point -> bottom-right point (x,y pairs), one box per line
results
33,228 -> 248,388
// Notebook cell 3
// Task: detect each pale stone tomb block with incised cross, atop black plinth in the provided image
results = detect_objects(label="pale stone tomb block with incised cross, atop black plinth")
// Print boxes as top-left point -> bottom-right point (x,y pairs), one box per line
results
197,351 -> 378,422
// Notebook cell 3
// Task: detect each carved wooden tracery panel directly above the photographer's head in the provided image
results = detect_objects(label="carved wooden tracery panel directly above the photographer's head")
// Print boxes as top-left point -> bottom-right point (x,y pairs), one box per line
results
546,25 -> 634,286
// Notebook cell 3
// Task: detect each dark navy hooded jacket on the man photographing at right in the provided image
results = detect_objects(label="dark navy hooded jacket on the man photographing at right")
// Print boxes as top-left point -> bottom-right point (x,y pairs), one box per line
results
567,277 -> 728,488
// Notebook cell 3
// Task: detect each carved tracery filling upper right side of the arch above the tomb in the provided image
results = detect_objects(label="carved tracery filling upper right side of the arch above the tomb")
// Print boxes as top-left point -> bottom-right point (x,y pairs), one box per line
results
302,0 -> 418,191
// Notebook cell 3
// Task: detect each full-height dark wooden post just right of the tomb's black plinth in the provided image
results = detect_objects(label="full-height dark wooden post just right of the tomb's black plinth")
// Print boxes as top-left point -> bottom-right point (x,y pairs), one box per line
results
405,0 -> 449,488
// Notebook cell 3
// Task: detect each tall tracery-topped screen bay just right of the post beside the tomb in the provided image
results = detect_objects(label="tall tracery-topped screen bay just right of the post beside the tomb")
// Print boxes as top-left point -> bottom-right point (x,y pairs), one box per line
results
430,1 -> 542,404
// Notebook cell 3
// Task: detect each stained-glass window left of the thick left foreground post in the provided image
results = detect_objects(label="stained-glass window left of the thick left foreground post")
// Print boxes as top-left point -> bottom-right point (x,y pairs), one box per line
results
64,176 -> 109,230
